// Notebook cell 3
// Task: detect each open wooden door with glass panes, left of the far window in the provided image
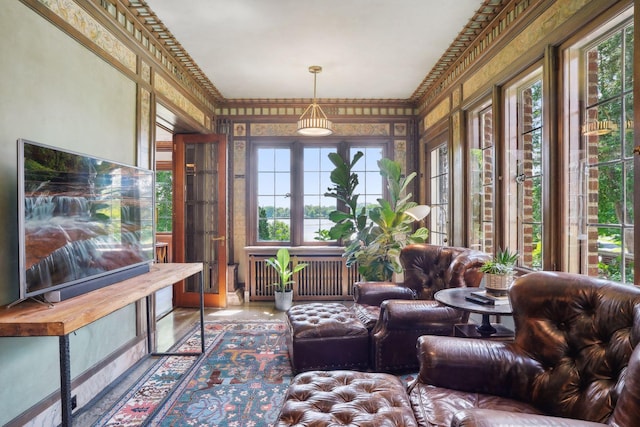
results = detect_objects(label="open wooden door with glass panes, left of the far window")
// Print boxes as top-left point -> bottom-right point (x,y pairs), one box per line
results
173,134 -> 227,307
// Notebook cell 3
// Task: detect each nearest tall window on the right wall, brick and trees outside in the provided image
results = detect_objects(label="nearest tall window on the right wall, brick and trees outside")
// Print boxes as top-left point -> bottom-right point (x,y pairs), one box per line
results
567,15 -> 634,283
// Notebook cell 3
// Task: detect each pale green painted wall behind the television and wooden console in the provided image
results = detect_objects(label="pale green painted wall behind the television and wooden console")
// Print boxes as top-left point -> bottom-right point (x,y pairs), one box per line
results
0,1 -> 136,425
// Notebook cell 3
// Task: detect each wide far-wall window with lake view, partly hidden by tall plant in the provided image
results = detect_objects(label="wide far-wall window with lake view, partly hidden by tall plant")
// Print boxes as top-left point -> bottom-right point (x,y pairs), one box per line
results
251,141 -> 387,246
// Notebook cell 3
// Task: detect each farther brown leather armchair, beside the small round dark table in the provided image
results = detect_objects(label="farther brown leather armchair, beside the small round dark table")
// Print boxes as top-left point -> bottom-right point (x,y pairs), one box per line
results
353,243 -> 490,372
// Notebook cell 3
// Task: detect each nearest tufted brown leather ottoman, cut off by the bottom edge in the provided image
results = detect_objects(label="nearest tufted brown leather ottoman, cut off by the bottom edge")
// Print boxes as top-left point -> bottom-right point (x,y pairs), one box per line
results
276,371 -> 418,427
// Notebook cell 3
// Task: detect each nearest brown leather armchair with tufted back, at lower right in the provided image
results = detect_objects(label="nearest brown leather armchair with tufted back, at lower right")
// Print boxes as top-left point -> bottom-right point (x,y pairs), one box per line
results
409,272 -> 640,427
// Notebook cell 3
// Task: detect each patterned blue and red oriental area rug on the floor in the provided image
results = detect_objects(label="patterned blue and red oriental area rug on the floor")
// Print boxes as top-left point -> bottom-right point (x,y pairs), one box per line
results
94,321 -> 292,427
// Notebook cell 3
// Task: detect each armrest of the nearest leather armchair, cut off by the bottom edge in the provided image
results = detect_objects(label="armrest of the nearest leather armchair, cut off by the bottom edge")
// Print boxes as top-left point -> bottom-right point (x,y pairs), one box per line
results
451,409 -> 606,427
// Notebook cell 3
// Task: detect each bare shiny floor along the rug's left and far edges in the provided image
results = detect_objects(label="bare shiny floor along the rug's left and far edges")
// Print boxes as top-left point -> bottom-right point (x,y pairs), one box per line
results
74,302 -> 285,426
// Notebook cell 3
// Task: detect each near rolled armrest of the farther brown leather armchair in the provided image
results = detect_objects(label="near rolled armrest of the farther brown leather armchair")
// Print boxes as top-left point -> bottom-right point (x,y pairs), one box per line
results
380,300 -> 468,332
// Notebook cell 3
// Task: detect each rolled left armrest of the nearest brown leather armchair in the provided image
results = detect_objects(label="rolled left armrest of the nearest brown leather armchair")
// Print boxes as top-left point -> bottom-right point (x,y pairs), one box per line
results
417,335 -> 543,402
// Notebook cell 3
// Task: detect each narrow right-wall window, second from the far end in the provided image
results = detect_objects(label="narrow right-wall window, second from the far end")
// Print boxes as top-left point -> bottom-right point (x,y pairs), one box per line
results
468,104 -> 495,253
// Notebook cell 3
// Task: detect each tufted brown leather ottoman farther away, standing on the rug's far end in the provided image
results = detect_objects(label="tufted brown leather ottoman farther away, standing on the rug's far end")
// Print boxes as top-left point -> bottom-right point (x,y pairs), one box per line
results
287,303 -> 369,372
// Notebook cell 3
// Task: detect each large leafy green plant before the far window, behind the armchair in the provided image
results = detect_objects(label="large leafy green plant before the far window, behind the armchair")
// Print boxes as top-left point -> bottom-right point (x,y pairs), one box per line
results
325,152 -> 429,281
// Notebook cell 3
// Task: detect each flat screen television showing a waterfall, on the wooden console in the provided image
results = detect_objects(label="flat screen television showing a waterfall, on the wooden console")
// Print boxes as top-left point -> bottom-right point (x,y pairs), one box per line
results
18,139 -> 155,302
